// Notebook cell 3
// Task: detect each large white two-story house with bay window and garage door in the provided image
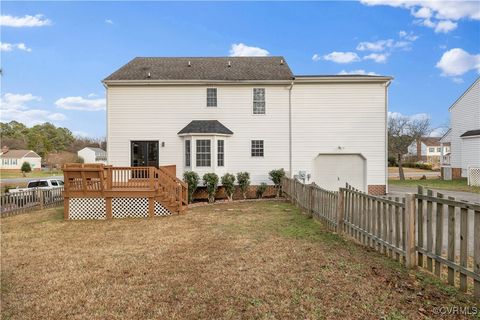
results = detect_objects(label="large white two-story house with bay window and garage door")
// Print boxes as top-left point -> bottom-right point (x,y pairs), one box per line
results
103,57 -> 392,194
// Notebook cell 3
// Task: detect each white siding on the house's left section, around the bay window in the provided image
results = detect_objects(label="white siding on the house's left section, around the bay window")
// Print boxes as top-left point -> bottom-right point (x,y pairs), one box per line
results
107,83 -> 288,184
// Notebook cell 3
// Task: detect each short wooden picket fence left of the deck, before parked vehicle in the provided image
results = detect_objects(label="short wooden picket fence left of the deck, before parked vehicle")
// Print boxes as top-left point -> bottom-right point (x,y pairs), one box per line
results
0,187 -> 63,217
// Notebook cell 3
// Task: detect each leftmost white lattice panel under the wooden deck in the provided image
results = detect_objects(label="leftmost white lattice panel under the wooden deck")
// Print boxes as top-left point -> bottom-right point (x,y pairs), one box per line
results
68,198 -> 107,220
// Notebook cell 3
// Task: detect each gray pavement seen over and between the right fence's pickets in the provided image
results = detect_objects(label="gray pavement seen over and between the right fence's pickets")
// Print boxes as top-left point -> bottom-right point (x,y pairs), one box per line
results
387,185 -> 480,255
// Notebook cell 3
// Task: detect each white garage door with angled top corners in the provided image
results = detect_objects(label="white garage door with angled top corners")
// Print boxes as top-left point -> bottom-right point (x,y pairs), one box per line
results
313,154 -> 366,191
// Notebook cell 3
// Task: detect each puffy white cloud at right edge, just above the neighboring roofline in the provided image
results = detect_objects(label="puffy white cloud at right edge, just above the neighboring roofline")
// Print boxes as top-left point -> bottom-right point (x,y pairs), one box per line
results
436,48 -> 480,76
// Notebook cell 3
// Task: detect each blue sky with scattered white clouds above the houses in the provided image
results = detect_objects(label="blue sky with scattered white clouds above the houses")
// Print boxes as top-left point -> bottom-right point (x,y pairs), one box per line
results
1,0 -> 480,137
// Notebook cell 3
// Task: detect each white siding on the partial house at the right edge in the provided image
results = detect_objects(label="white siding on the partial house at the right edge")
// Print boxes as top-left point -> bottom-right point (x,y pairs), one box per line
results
449,80 -> 480,177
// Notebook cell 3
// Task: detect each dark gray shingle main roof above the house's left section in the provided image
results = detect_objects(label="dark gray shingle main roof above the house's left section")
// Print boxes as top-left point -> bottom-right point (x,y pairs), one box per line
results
104,57 -> 293,81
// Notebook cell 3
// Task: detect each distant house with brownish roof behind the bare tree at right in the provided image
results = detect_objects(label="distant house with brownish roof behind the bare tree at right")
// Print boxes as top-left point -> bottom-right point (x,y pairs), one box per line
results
406,137 -> 450,166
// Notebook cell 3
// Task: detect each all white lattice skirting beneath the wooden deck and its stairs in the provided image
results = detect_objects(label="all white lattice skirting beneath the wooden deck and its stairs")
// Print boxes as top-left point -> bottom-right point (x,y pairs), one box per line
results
69,198 -> 172,220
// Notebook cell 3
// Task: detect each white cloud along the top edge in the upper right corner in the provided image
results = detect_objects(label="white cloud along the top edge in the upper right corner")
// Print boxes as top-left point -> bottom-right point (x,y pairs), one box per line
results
360,0 -> 480,33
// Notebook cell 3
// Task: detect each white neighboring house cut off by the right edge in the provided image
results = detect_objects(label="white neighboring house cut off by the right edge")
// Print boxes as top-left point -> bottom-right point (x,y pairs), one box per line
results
441,78 -> 480,185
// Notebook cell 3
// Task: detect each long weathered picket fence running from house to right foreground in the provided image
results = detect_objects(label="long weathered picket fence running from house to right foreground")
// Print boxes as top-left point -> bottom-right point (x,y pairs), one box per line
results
282,178 -> 480,300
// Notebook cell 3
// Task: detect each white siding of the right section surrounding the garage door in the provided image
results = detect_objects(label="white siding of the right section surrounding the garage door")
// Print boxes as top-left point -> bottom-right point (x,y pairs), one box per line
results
292,83 -> 387,185
